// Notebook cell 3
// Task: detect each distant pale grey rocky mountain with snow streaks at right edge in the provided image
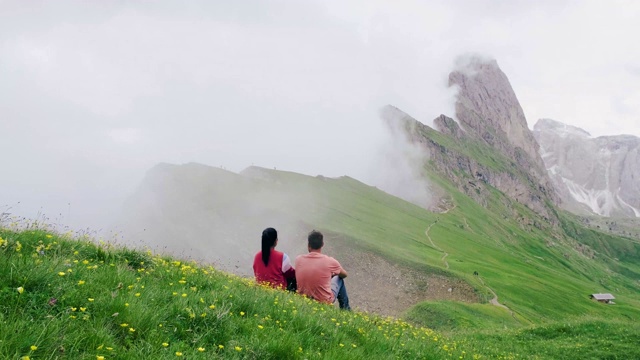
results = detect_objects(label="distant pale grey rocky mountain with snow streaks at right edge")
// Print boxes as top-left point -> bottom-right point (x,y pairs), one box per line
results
534,119 -> 640,217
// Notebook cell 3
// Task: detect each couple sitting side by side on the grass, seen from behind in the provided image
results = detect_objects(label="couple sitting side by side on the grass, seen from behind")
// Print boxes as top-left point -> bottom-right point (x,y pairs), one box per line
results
253,228 -> 351,310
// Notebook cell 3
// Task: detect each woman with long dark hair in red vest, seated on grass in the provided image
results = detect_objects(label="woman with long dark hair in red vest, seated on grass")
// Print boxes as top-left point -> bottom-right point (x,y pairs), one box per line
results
253,228 -> 296,289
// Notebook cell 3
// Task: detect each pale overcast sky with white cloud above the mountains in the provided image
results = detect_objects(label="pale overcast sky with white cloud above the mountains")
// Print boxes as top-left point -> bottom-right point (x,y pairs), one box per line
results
0,0 -> 640,226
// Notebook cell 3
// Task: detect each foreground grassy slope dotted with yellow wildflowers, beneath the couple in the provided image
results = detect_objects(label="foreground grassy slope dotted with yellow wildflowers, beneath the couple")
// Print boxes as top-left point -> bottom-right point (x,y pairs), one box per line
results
0,230 -> 640,360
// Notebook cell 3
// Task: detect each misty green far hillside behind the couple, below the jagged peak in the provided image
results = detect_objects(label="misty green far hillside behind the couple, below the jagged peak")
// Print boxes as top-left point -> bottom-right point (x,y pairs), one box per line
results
116,162 -> 640,331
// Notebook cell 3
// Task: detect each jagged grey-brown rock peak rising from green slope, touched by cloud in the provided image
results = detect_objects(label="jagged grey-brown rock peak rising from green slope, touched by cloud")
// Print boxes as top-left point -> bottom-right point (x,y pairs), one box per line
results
382,58 -> 559,224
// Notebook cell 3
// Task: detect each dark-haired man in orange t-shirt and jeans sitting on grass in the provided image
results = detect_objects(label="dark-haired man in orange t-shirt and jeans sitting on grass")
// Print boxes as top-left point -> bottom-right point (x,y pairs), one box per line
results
296,230 -> 351,310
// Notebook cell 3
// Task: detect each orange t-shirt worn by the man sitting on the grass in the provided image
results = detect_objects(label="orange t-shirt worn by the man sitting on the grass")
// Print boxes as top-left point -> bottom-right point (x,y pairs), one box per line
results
296,252 -> 342,304
